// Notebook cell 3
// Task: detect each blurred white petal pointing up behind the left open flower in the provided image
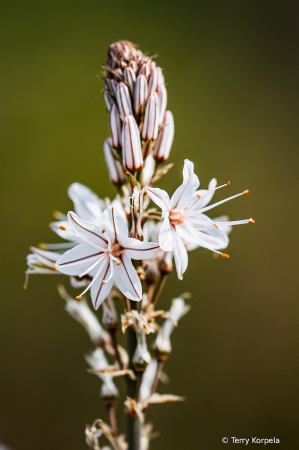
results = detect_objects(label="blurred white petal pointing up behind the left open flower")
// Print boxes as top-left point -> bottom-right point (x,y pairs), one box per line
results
68,183 -> 102,222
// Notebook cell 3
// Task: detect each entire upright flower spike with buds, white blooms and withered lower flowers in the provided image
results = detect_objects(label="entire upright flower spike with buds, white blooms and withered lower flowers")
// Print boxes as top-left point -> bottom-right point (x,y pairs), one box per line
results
26,41 -> 254,450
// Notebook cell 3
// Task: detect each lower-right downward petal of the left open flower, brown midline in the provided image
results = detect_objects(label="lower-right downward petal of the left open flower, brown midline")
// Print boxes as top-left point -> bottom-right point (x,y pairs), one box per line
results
114,252 -> 142,301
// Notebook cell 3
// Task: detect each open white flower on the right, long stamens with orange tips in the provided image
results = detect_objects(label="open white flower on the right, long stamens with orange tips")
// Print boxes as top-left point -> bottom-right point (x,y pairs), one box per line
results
146,159 -> 254,280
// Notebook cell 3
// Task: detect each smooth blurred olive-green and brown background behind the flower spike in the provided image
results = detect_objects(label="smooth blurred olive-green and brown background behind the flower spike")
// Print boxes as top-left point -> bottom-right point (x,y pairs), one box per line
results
0,0 -> 299,450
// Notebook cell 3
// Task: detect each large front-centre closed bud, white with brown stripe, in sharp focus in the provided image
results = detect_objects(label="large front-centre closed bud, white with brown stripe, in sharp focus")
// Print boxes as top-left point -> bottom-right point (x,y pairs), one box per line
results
122,116 -> 143,172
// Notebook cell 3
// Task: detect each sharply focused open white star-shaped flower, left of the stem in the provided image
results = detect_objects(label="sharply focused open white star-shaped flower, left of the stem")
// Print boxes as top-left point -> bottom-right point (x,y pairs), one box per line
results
54,206 -> 159,309
